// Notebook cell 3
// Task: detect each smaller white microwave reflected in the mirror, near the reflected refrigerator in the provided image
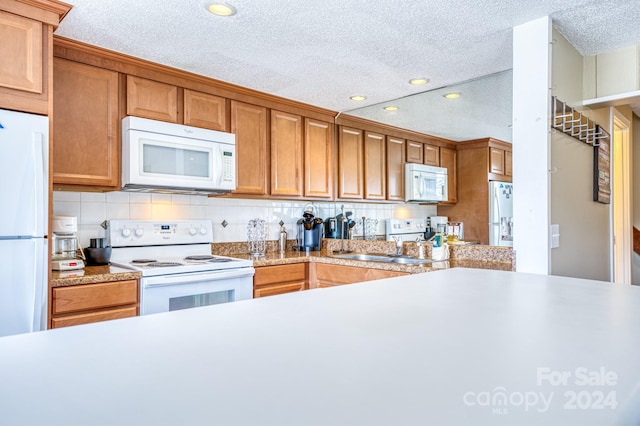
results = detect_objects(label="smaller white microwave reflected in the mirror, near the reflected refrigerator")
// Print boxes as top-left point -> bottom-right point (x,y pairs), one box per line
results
404,163 -> 449,203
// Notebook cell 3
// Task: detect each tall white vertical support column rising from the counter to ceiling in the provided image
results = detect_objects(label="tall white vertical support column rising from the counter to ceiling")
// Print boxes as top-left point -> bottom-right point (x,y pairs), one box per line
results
513,16 -> 552,274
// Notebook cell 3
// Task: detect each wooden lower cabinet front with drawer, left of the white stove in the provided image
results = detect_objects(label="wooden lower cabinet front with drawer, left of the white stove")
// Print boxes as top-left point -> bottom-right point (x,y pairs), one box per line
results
51,280 -> 139,328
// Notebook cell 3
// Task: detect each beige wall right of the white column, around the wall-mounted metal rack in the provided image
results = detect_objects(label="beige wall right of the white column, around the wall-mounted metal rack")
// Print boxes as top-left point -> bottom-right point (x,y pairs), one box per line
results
550,31 -> 610,281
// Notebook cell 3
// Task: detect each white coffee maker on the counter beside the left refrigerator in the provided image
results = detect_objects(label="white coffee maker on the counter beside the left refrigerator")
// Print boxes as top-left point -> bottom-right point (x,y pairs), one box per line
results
51,216 -> 84,271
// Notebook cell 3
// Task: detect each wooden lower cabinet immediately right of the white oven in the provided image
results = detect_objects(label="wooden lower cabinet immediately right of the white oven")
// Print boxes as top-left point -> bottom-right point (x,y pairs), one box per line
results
253,263 -> 307,298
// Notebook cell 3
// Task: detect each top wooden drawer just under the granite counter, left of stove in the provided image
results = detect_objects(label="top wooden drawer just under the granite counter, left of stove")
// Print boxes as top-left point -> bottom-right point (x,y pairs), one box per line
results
51,280 -> 138,315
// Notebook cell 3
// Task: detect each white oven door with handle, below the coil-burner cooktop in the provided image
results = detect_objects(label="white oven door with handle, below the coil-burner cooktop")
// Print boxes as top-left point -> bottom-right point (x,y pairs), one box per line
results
140,268 -> 255,315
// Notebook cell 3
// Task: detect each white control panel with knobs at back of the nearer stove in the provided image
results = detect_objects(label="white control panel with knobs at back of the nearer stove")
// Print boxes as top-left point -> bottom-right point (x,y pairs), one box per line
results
107,220 -> 213,247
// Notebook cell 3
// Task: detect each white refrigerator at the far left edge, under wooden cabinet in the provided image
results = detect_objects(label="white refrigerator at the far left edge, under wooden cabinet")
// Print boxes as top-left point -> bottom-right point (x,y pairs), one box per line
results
0,109 -> 49,336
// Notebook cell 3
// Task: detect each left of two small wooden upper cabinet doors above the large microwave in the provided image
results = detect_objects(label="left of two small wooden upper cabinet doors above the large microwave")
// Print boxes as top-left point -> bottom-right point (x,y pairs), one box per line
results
127,75 -> 178,123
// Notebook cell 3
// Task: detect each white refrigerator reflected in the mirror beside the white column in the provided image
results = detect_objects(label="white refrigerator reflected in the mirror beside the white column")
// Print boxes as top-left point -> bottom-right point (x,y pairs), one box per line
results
489,181 -> 513,247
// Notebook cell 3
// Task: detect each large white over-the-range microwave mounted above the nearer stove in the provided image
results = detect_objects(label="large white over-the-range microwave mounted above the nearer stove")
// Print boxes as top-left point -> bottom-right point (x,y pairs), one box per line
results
122,117 -> 237,194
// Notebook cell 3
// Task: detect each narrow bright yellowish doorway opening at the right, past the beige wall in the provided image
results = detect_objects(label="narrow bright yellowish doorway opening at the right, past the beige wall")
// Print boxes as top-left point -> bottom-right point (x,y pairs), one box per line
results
611,108 -> 633,284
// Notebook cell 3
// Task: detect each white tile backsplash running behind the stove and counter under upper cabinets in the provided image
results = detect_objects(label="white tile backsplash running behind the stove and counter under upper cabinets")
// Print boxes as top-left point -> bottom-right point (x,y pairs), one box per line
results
53,191 -> 437,247
